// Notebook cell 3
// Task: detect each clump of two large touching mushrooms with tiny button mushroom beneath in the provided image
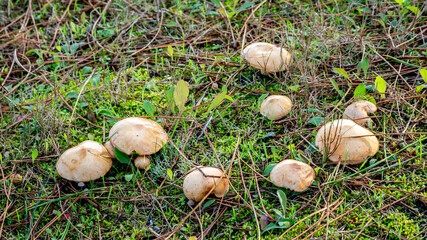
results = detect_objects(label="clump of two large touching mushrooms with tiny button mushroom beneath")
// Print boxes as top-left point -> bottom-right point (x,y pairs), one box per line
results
56,117 -> 168,182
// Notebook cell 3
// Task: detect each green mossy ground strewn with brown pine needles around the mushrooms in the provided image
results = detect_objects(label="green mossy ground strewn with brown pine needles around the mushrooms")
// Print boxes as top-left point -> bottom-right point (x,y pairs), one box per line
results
0,0 -> 427,239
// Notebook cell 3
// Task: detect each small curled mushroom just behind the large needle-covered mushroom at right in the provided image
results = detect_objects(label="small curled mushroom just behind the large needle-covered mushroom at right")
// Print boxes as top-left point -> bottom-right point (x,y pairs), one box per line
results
343,100 -> 377,126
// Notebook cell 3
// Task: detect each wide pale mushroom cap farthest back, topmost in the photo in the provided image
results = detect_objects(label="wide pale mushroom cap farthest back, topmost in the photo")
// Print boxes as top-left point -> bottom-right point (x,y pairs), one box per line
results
242,42 -> 291,72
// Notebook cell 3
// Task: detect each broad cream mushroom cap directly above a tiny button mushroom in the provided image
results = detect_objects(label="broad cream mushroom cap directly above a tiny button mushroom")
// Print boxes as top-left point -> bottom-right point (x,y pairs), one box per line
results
109,117 -> 168,155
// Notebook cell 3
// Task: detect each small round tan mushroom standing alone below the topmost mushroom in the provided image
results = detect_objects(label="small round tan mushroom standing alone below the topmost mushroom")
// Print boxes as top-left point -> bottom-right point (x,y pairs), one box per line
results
260,95 -> 292,120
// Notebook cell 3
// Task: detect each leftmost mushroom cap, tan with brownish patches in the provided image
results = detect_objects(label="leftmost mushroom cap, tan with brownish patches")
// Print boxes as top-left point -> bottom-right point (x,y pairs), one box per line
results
56,140 -> 113,182
